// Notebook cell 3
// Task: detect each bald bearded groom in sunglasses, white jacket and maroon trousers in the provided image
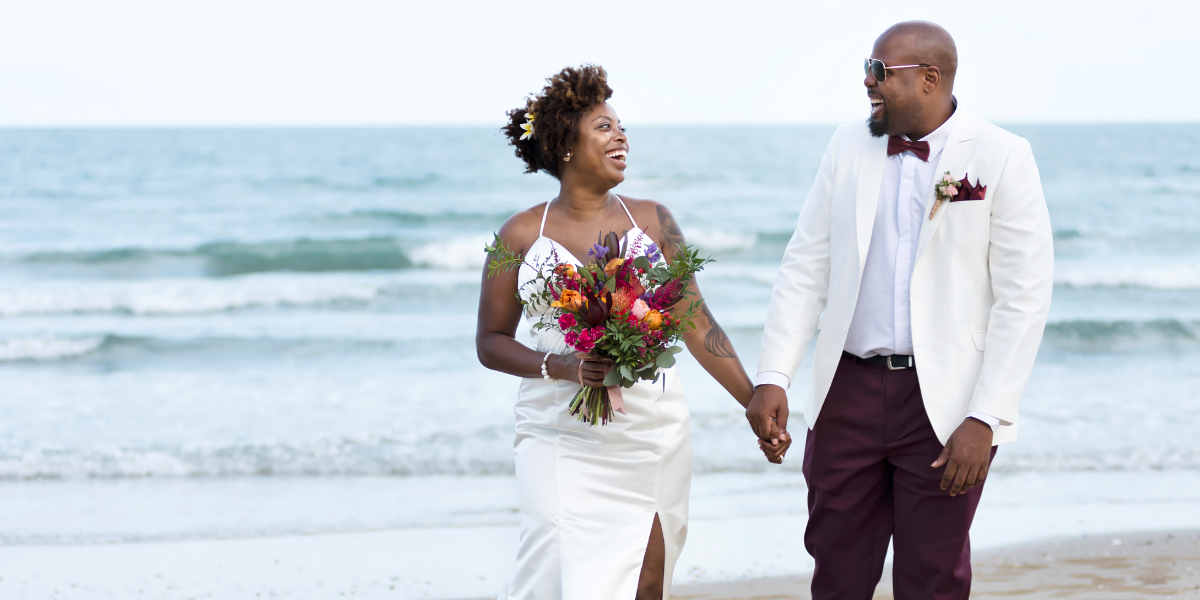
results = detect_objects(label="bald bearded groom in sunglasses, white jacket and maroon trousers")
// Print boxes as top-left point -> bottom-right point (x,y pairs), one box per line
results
746,22 -> 1054,600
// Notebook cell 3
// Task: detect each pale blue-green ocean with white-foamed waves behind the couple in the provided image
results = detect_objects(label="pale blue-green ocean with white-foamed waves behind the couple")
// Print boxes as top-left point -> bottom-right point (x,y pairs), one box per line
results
0,125 -> 1200,556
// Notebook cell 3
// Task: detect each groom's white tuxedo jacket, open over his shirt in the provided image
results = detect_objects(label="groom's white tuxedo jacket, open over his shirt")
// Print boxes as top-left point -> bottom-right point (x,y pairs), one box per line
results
758,112 -> 1054,444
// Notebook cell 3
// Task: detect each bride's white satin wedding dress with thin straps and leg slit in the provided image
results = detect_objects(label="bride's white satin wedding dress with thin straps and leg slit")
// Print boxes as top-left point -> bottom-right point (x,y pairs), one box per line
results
499,198 -> 691,600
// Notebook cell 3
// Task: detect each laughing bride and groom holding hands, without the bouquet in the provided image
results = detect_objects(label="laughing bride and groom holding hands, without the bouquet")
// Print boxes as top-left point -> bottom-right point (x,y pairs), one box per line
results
476,22 -> 1054,600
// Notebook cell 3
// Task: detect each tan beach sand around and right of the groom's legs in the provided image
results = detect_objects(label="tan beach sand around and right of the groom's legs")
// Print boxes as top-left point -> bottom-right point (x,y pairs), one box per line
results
673,532 -> 1200,600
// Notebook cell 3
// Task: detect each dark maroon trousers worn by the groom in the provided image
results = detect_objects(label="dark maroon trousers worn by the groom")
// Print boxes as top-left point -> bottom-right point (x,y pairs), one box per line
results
804,355 -> 996,600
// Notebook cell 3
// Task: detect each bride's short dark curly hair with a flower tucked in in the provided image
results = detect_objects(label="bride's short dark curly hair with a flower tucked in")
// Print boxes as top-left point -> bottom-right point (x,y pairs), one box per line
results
500,65 -> 612,179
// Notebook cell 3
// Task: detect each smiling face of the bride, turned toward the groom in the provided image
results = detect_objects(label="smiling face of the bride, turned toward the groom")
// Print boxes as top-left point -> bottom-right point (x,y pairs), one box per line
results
563,102 -> 629,188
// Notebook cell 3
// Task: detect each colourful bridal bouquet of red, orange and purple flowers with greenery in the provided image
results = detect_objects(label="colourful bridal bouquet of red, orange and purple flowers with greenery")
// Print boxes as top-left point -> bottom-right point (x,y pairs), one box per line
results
485,232 -> 712,425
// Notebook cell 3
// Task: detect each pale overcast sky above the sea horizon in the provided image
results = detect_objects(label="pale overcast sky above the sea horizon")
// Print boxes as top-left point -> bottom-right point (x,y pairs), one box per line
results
0,0 -> 1200,126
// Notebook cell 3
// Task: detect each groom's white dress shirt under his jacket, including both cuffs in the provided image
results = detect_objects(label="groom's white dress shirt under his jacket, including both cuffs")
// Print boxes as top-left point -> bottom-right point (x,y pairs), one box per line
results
756,112 -> 1000,430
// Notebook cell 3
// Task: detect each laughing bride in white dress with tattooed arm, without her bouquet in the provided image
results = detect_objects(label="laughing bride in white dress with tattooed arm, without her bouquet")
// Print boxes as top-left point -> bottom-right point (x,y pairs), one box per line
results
475,65 -> 786,600
